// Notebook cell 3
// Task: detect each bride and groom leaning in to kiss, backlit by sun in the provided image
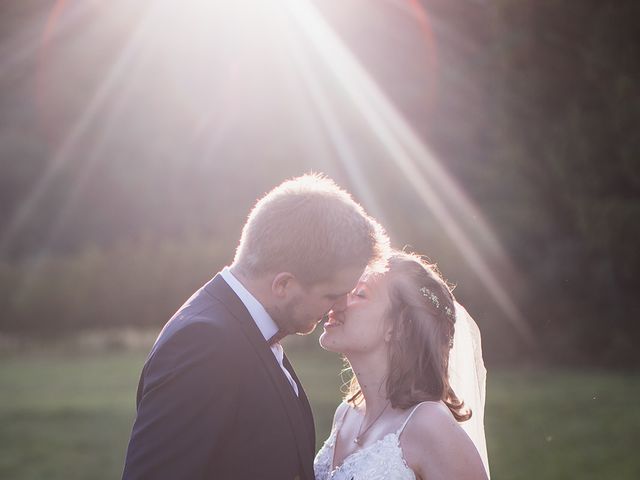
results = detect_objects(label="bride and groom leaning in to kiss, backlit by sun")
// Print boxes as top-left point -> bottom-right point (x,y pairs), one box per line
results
123,175 -> 488,480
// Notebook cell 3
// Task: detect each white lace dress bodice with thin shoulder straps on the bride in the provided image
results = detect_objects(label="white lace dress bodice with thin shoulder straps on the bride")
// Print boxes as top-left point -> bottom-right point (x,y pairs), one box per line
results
313,403 -> 422,480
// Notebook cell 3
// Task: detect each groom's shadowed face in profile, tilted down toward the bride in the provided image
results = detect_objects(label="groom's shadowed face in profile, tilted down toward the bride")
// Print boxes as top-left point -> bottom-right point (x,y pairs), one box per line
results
278,267 -> 363,334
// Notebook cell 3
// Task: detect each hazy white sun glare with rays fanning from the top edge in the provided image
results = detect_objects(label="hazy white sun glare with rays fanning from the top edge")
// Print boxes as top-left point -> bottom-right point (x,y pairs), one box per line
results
5,0 -> 533,340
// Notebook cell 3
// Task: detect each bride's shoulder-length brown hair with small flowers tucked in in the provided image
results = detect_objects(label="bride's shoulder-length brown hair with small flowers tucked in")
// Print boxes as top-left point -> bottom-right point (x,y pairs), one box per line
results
346,252 -> 471,422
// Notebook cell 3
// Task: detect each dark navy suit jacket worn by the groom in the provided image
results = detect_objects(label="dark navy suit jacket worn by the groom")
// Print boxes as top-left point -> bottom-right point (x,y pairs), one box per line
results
122,275 -> 315,480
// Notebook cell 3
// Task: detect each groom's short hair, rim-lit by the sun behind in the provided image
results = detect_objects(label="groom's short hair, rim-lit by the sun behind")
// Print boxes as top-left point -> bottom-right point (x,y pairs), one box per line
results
234,174 -> 389,285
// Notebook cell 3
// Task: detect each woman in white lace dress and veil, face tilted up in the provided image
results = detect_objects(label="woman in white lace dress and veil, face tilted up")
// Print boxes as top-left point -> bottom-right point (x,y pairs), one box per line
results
314,252 -> 488,480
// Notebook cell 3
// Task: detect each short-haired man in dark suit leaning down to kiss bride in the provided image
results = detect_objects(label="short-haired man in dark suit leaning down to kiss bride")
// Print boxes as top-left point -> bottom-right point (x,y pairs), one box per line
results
123,175 -> 388,480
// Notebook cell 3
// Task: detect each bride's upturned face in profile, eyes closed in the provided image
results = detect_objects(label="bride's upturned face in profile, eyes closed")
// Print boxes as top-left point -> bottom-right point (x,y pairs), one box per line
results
320,272 -> 390,355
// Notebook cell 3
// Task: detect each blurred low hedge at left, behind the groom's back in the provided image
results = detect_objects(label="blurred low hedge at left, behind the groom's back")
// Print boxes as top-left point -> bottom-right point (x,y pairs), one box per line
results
0,239 -> 231,335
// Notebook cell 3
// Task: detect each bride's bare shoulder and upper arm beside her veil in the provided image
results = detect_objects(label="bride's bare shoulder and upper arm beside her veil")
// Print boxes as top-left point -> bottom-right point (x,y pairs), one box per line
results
400,403 -> 487,480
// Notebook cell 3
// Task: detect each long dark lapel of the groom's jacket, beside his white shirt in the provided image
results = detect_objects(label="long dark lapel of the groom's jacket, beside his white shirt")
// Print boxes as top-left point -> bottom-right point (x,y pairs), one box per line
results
205,275 -> 315,478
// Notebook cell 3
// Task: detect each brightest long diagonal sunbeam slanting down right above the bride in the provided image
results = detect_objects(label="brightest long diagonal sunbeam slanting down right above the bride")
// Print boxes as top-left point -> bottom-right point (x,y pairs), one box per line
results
289,0 -> 535,345
